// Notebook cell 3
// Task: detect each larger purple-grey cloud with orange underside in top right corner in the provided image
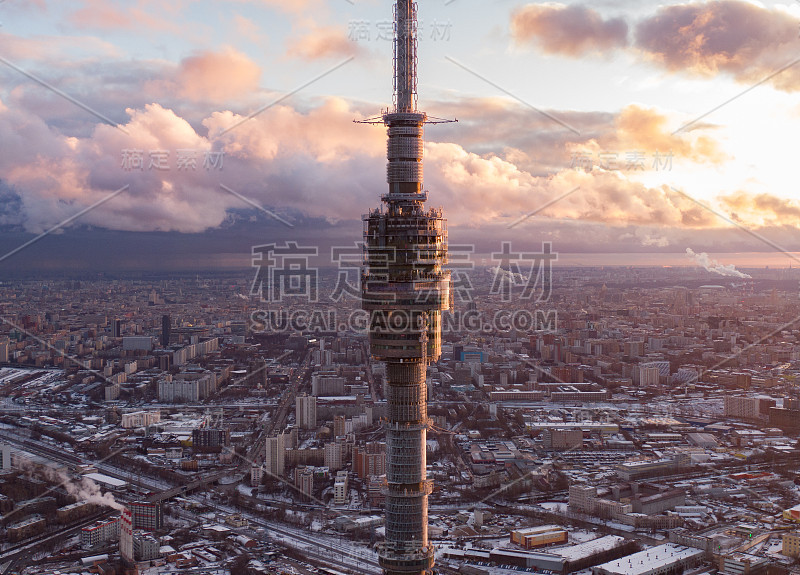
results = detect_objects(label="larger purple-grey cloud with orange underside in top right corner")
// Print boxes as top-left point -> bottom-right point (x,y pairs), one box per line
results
635,0 -> 800,91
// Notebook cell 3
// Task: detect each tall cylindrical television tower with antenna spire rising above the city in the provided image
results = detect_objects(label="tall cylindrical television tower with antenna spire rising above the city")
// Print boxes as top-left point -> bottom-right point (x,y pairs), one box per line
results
361,0 -> 450,575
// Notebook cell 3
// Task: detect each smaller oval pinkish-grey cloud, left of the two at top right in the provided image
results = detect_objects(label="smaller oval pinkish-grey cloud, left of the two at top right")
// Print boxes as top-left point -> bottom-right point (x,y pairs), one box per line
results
511,4 -> 628,57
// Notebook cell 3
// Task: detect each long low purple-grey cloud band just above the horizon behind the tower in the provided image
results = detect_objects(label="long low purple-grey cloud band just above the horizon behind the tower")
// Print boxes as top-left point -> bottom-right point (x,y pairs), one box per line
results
0,218 -> 800,281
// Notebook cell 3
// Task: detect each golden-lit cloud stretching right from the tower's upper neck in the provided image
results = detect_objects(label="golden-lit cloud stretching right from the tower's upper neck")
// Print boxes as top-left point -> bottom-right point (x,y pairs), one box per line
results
426,98 -> 729,177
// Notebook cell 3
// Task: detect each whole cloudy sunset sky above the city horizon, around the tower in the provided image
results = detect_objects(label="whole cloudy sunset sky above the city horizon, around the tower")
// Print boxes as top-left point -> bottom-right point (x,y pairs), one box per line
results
0,0 -> 800,273
